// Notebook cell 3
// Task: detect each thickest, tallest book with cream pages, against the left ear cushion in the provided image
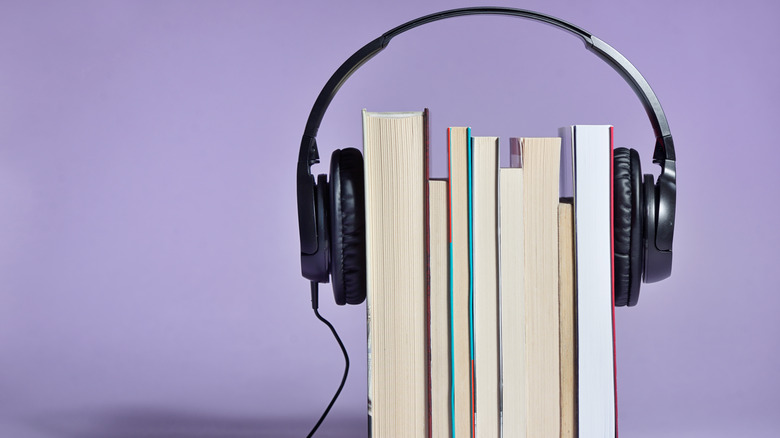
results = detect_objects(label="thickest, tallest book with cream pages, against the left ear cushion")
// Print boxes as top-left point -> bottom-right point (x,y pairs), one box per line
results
363,110 -> 428,438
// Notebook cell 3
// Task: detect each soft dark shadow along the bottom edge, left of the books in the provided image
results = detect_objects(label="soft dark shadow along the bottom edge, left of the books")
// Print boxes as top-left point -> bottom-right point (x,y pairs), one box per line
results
28,408 -> 367,438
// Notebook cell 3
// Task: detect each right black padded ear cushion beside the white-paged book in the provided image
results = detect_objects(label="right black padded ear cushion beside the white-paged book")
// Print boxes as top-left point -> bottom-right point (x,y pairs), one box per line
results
613,148 -> 644,306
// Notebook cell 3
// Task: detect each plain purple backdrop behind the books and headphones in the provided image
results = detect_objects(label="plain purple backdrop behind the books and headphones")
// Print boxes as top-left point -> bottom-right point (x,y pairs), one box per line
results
0,0 -> 780,438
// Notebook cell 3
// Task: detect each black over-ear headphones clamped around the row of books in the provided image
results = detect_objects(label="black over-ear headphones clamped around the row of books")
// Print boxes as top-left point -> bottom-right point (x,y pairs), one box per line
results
297,7 -> 677,306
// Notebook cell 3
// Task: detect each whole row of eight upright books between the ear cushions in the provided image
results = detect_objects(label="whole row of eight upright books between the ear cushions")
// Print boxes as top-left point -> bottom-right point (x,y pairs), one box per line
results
363,110 -> 617,438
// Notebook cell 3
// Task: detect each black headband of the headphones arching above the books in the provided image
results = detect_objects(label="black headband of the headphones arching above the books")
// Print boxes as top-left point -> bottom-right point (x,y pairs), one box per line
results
297,7 -> 676,254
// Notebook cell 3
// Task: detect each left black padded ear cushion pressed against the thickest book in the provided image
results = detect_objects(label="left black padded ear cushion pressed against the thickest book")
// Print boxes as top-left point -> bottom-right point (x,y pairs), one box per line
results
330,148 -> 366,305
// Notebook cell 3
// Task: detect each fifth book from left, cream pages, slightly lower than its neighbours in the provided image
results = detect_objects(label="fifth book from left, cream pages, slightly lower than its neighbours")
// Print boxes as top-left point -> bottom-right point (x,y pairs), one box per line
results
498,139 -> 526,438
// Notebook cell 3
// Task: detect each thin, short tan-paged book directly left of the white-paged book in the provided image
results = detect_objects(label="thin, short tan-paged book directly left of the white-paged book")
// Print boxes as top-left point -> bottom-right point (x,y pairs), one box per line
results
558,198 -> 577,438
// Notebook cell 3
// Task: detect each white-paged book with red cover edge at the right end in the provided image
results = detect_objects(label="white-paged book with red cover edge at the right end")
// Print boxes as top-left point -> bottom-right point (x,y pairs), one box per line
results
561,125 -> 617,438
